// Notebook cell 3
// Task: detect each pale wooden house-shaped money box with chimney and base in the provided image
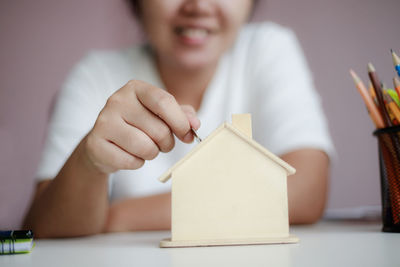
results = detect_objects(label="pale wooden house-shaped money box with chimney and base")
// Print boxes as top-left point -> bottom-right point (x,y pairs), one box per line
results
160,114 -> 298,247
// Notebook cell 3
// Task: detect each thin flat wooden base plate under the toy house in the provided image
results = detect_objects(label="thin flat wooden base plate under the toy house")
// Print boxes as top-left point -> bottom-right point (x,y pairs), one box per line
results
160,235 -> 299,248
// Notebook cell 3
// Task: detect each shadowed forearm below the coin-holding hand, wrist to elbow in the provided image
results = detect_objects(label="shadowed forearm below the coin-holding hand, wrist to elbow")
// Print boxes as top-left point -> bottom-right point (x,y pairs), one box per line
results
24,140 -> 109,237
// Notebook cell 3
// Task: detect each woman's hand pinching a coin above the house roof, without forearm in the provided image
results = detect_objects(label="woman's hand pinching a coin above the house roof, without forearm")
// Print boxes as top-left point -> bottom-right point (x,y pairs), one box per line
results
83,80 -> 200,174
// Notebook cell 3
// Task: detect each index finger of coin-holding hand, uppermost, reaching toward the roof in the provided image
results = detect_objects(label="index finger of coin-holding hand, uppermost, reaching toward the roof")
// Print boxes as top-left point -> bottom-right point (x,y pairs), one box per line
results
136,82 -> 191,141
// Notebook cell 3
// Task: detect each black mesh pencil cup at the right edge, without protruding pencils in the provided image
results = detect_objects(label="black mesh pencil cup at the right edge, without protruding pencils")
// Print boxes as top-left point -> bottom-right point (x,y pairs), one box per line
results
374,126 -> 400,233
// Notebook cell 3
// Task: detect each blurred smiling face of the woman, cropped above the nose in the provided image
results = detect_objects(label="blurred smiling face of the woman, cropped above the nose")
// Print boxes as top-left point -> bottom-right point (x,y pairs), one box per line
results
140,0 -> 253,69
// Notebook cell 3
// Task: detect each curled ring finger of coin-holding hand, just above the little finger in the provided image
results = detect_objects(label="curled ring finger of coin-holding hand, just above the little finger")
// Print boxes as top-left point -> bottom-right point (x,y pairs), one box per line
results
108,119 -> 159,160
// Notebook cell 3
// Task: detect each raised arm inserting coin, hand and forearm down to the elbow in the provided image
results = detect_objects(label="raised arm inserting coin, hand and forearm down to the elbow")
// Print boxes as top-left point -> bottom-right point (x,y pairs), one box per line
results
24,81 -> 200,237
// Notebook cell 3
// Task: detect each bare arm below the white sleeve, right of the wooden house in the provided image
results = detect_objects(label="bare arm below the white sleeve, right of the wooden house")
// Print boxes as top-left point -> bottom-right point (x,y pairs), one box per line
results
282,149 -> 329,224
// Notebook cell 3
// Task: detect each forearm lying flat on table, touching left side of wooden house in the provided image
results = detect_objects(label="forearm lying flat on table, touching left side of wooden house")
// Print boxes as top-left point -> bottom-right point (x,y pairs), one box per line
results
104,193 -> 171,232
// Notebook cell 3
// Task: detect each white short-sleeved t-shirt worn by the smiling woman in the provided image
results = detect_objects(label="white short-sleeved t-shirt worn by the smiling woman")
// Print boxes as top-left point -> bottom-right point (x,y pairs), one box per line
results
37,22 -> 334,203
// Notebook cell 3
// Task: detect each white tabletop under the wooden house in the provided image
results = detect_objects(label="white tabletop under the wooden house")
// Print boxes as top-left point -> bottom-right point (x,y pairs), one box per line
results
0,221 -> 400,267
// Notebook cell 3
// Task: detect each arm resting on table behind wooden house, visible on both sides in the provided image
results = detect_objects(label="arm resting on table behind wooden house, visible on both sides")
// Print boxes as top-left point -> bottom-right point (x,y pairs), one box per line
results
104,149 -> 329,232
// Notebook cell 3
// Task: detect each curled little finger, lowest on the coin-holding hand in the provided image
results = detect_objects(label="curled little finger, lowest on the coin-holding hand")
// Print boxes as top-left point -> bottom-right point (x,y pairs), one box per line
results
88,138 -> 144,173
